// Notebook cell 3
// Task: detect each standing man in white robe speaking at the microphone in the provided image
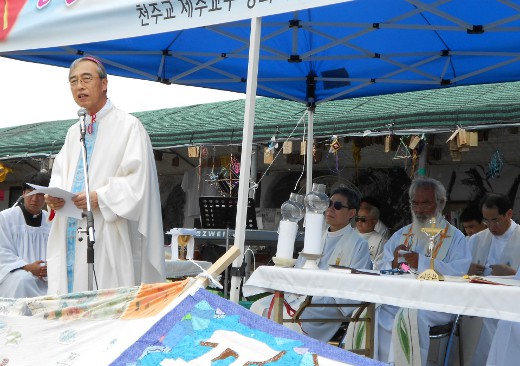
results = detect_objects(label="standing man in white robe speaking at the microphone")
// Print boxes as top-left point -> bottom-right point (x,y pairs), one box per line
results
45,57 -> 165,294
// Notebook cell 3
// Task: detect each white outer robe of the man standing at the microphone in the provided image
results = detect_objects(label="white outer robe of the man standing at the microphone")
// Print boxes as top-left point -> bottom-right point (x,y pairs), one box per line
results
47,101 -> 165,294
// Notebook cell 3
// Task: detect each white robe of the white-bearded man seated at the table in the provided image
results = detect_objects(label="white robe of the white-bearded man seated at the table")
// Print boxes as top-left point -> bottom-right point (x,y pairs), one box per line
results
376,220 -> 471,365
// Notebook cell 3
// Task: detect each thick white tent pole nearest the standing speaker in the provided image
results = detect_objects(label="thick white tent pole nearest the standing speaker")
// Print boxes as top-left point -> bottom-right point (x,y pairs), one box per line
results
229,18 -> 262,303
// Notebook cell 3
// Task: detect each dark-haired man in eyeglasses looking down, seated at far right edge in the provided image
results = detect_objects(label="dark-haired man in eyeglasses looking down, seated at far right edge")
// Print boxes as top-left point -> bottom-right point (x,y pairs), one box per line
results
468,193 -> 520,366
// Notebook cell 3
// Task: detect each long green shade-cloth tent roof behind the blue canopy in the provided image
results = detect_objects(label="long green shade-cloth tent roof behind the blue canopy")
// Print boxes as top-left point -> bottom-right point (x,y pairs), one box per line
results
0,82 -> 520,159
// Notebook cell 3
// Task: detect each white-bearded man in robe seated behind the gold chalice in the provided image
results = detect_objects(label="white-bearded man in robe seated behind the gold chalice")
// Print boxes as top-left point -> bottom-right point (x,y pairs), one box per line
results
376,177 -> 471,365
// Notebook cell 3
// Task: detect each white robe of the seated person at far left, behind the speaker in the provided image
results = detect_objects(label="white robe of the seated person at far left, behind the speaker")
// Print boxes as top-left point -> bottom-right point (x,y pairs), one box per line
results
0,207 -> 50,298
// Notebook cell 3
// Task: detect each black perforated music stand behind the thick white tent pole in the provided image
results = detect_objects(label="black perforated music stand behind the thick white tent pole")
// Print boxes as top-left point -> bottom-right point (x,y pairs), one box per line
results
199,196 -> 258,298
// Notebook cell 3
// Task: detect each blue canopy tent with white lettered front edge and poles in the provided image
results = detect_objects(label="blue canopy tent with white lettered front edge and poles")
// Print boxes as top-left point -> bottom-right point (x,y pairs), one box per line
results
0,0 -> 520,300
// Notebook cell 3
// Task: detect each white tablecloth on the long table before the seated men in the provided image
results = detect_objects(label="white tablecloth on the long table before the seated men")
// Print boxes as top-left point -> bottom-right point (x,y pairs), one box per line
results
242,266 -> 520,322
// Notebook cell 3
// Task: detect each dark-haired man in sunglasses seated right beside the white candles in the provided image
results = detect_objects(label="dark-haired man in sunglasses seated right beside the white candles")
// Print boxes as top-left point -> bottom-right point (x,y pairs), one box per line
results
251,187 -> 372,342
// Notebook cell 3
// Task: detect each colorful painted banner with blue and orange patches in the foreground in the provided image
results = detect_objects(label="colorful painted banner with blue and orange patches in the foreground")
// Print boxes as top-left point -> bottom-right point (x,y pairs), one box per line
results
0,280 -> 381,366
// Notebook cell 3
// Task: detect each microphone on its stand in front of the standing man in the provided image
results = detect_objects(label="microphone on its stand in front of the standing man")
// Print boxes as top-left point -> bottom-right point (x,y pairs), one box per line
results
78,109 -> 96,291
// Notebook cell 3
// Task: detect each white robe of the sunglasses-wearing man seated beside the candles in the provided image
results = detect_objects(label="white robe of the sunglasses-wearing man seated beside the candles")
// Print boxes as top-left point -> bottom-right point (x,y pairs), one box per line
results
251,225 -> 372,342
